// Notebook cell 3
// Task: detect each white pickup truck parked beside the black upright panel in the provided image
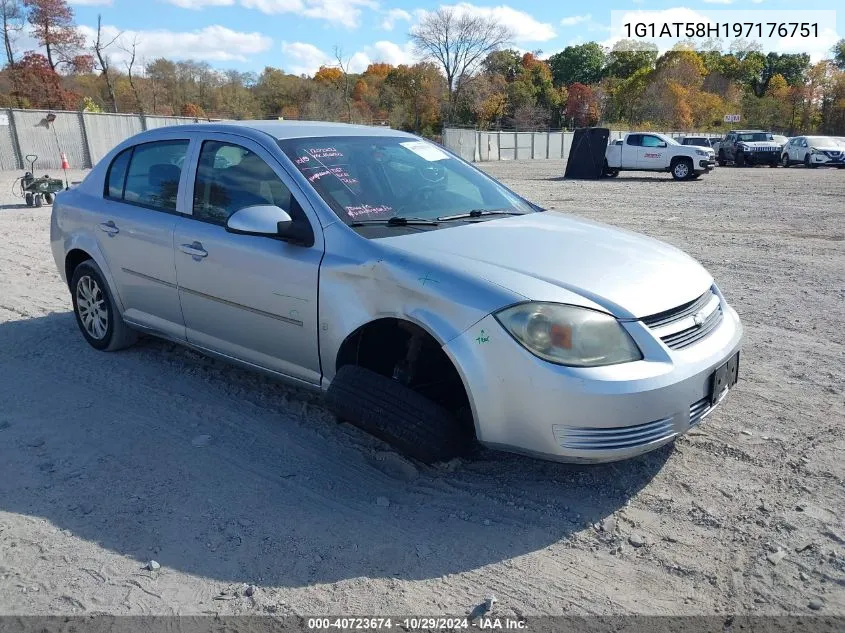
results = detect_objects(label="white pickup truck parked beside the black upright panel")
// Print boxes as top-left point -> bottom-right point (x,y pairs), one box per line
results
604,132 -> 716,180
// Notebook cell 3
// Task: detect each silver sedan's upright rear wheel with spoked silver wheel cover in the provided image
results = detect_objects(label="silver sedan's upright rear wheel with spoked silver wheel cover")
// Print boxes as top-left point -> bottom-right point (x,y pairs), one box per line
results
70,259 -> 138,352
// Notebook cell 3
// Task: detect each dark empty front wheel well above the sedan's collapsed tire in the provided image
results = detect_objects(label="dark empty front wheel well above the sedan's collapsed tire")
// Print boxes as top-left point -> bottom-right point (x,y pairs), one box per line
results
335,318 -> 474,431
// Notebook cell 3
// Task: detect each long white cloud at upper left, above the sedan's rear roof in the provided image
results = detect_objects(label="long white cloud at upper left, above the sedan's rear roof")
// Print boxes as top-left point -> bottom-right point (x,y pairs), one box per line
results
79,25 -> 273,63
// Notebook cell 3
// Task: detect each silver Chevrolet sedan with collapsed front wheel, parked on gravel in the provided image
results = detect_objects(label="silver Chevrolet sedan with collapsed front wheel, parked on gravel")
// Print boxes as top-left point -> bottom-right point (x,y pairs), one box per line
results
50,121 -> 742,462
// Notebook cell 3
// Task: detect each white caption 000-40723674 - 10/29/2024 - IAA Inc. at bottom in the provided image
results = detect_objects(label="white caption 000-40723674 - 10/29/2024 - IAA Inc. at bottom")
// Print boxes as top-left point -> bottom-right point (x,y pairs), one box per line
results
306,616 -> 527,631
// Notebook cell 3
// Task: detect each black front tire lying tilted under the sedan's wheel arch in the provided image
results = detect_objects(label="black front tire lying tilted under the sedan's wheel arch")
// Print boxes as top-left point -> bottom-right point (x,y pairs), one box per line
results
326,365 -> 472,464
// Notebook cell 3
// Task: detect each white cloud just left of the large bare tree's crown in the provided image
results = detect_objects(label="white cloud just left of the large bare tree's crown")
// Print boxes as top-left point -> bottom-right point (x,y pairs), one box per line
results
282,40 -> 417,75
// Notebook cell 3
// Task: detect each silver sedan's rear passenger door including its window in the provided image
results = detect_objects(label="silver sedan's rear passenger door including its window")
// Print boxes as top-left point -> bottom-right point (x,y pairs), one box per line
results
94,138 -> 190,339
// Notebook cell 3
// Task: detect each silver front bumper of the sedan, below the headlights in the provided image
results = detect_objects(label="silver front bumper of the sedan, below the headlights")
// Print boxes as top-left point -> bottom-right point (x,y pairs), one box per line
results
444,300 -> 742,463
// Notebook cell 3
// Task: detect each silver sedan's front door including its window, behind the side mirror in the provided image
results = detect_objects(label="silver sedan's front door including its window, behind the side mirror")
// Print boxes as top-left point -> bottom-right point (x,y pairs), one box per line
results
174,134 -> 323,384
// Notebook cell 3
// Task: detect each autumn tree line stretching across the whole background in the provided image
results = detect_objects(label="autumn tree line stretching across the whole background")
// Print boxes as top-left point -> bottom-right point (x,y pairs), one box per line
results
0,0 -> 845,136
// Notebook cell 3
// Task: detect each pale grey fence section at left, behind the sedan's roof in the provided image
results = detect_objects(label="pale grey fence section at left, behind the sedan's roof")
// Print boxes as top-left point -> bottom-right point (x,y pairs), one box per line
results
0,108 -> 206,175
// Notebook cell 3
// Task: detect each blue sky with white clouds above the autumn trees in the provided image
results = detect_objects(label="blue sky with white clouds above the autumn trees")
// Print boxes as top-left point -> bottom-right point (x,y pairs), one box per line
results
46,0 -> 845,74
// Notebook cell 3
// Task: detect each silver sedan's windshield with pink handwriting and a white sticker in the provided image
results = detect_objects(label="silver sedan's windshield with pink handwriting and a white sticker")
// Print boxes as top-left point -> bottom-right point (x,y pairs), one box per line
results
279,136 -> 536,224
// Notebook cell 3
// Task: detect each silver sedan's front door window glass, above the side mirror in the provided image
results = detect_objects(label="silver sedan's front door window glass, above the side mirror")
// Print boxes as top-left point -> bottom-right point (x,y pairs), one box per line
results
193,141 -> 302,225
